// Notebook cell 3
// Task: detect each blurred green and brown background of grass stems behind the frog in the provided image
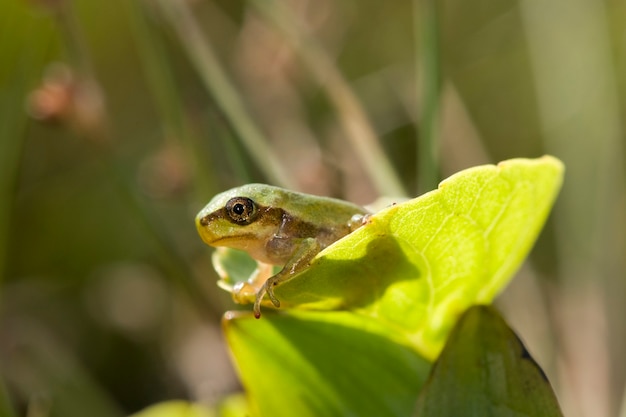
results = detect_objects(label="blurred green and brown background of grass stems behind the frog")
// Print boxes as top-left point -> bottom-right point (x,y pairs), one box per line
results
0,0 -> 626,417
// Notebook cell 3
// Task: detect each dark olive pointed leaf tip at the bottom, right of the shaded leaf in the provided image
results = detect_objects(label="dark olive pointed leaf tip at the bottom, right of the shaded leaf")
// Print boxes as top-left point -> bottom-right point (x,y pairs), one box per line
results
414,306 -> 563,417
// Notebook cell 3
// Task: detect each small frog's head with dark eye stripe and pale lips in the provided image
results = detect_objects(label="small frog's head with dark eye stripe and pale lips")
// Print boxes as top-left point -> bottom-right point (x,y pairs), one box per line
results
196,184 -> 282,260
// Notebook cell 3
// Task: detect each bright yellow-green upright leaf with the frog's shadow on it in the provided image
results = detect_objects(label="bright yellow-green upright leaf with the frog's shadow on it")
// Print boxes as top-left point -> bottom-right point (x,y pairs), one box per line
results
217,156 -> 563,359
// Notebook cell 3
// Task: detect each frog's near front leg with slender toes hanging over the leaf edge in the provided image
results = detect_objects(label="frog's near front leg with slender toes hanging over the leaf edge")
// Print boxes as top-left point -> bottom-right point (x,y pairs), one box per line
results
254,238 -> 321,319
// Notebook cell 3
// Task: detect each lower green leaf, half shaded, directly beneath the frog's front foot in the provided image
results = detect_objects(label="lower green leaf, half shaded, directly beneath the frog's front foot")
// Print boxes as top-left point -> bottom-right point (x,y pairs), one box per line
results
224,311 -> 430,417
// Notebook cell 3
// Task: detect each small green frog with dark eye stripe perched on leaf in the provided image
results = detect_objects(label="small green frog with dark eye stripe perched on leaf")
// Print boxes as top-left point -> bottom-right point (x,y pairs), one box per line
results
196,184 -> 368,318
